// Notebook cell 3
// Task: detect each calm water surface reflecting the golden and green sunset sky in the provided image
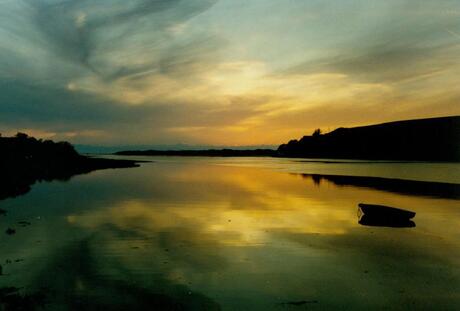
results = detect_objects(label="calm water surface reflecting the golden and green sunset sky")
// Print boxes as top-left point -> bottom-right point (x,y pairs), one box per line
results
0,157 -> 460,310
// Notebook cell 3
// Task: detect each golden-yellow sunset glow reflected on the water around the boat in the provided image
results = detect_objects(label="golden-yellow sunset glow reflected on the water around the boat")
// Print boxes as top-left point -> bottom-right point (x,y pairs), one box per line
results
67,164 -> 460,246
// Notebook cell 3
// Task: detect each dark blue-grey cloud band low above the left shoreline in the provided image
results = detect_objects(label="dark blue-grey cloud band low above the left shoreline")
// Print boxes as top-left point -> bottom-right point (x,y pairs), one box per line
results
0,82 -> 266,143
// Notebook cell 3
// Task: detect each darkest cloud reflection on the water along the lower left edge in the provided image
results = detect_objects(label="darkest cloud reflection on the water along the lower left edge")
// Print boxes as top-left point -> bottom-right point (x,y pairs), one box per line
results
32,236 -> 220,310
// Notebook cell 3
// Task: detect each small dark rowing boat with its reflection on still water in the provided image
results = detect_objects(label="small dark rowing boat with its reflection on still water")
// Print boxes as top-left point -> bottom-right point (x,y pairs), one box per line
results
358,203 -> 415,228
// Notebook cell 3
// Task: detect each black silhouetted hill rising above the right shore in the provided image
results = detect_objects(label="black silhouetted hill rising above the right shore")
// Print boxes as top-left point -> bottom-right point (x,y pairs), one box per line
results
277,116 -> 460,162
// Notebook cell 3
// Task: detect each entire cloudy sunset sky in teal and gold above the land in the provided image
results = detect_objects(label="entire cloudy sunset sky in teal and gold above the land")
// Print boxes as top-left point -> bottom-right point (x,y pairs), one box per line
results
0,0 -> 460,146
